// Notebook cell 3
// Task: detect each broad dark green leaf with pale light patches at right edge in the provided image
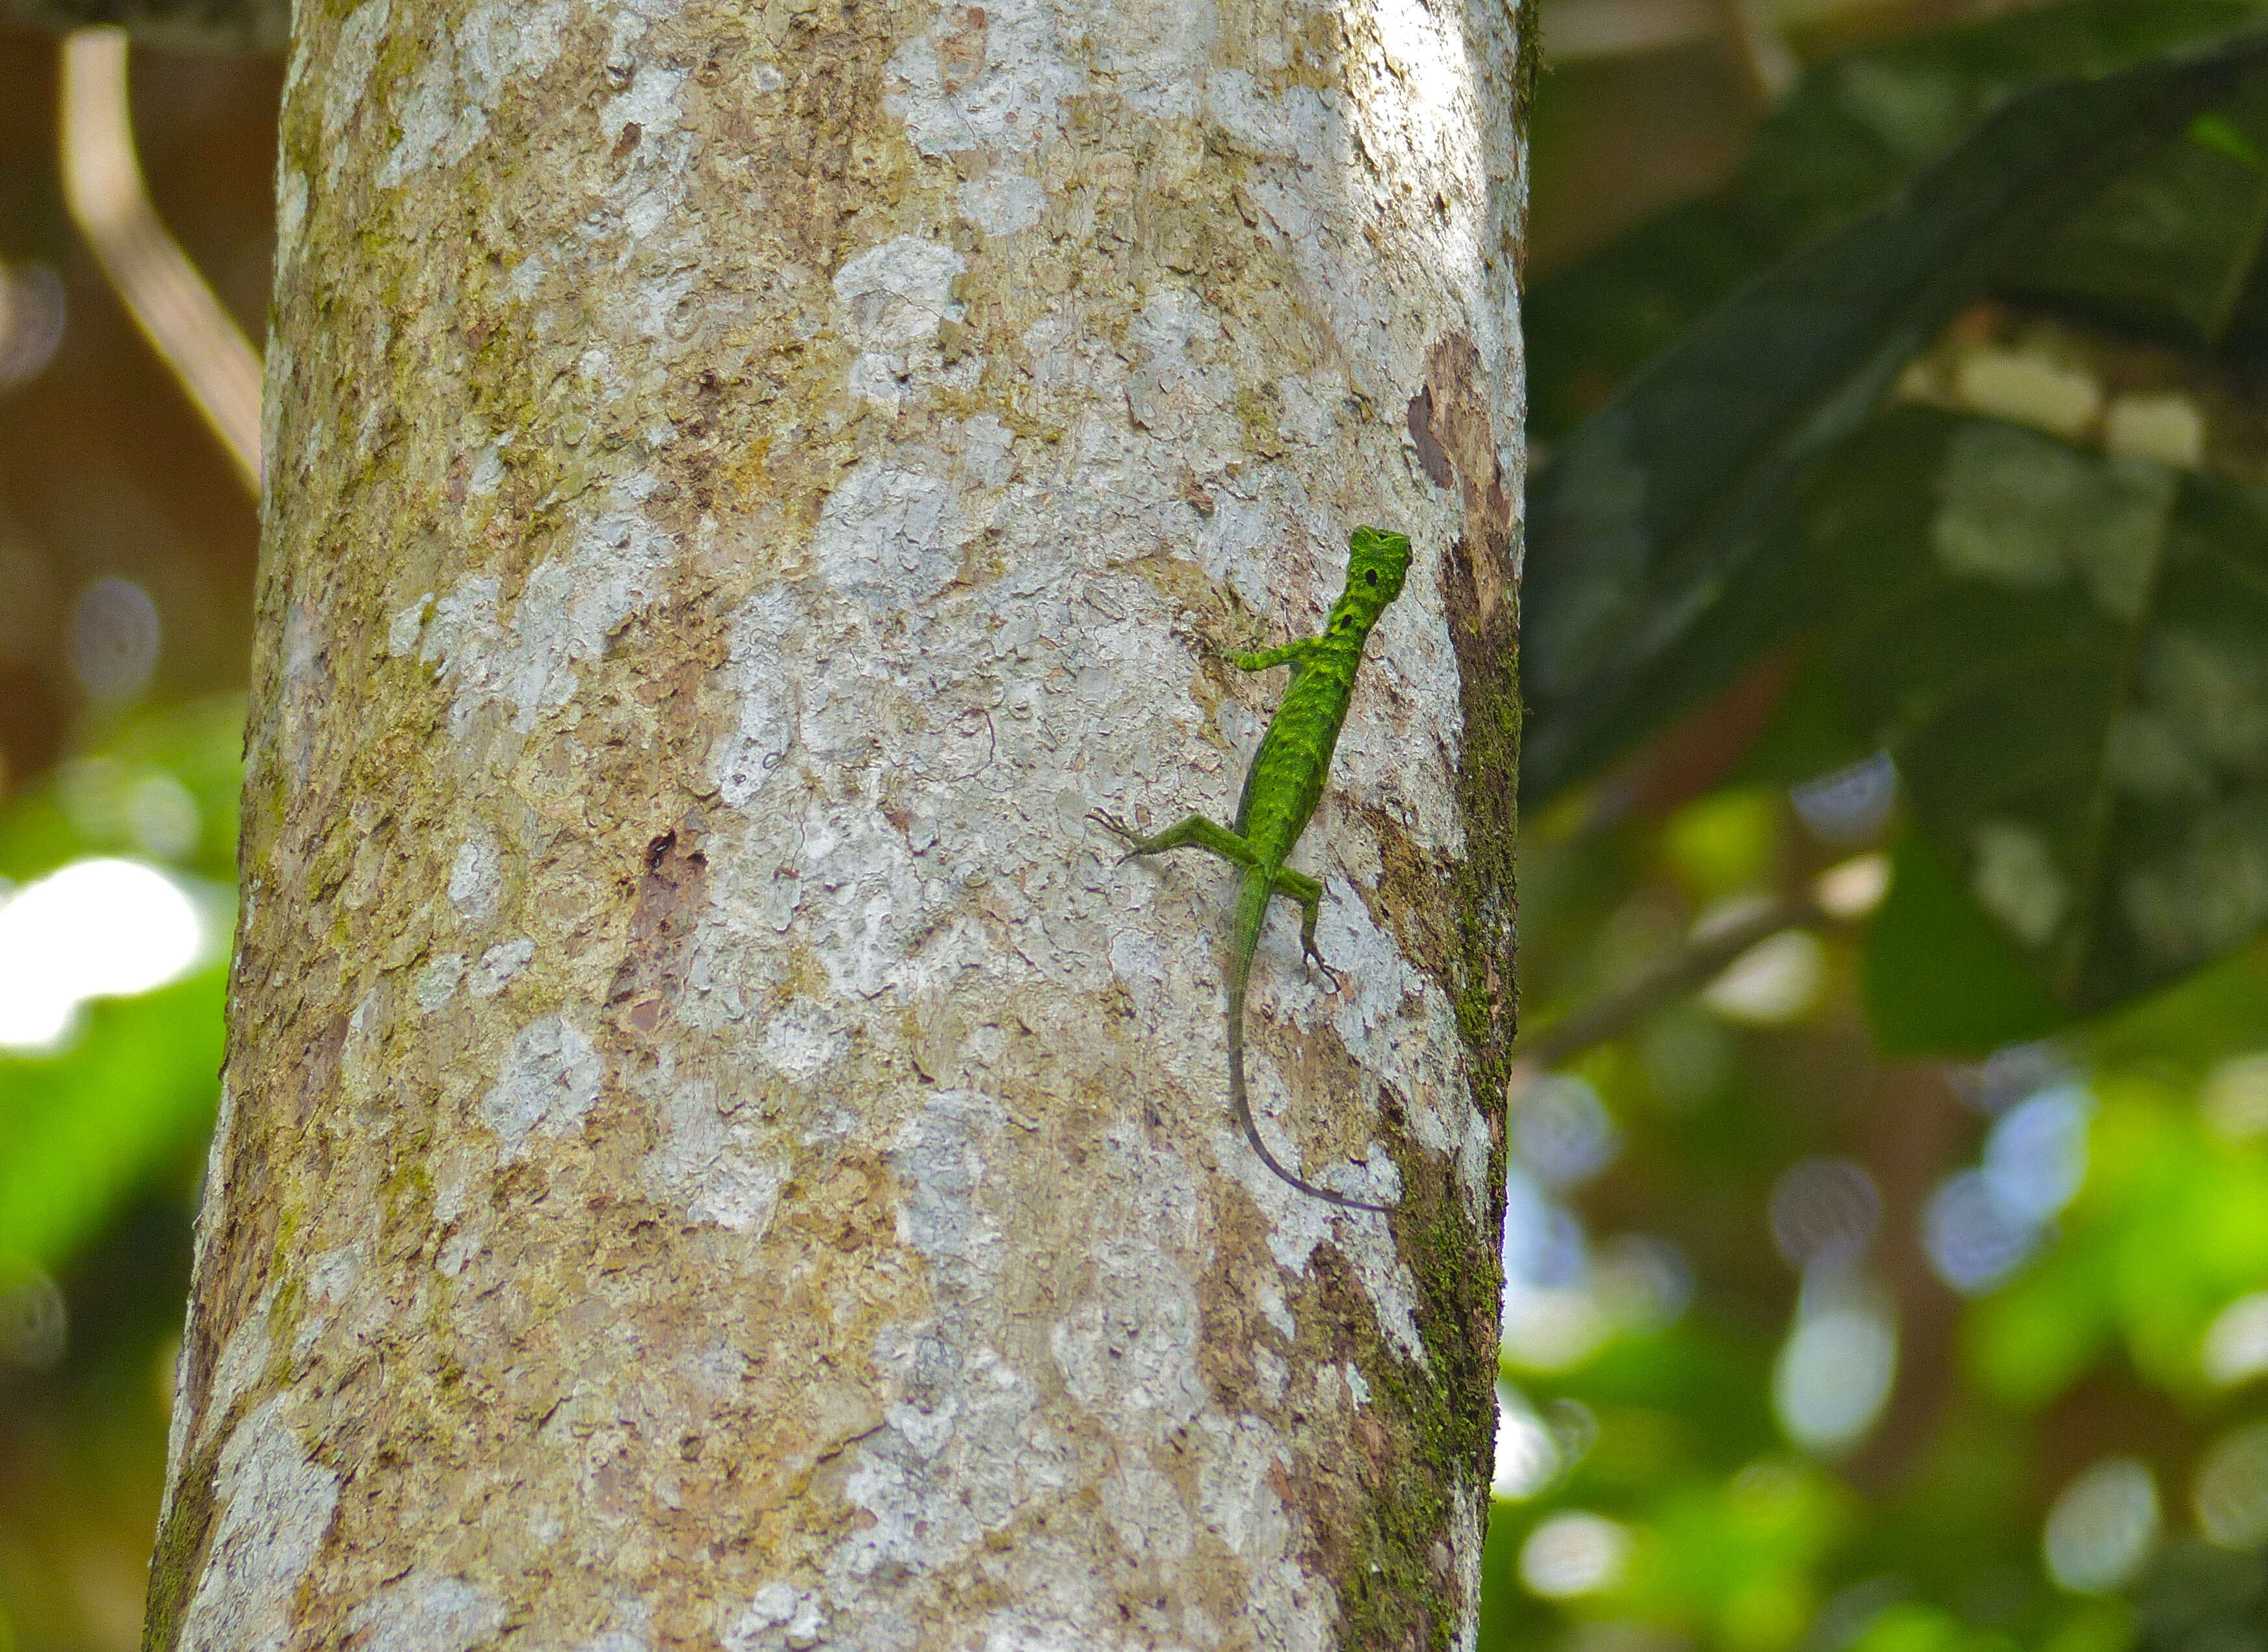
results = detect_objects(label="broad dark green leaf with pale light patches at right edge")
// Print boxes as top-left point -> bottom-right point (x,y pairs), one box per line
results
1805,408 -> 2268,1014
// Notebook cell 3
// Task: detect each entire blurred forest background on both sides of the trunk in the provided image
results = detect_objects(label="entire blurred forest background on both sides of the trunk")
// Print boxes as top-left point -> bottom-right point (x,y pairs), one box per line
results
0,0 -> 2268,1652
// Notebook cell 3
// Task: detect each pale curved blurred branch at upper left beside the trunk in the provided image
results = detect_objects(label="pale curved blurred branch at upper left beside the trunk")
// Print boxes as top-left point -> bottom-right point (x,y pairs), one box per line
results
61,27 -> 261,497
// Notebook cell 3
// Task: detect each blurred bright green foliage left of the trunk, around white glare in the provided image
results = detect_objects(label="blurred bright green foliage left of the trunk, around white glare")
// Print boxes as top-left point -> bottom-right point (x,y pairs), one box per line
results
0,694 -> 243,1652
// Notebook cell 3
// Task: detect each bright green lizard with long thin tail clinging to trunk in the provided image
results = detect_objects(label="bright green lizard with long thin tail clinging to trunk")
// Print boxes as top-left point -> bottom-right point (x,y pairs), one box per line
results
1088,529 -> 1411,1212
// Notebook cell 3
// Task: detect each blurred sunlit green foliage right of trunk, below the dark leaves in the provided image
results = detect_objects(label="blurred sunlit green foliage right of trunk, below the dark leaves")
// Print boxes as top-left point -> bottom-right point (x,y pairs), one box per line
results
1481,787 -> 2268,1652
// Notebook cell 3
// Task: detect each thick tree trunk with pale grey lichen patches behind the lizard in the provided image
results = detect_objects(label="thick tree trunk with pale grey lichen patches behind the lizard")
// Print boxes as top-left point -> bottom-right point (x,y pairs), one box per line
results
148,0 -> 1529,1652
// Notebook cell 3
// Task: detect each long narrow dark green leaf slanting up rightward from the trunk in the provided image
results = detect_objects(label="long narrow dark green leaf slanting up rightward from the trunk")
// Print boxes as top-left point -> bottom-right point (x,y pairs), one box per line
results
1522,19 -> 2268,804
